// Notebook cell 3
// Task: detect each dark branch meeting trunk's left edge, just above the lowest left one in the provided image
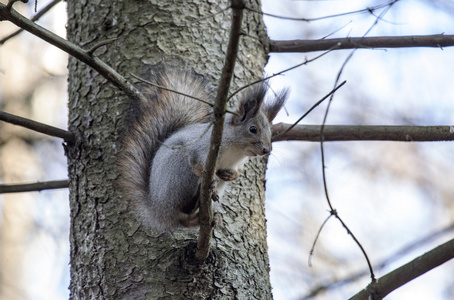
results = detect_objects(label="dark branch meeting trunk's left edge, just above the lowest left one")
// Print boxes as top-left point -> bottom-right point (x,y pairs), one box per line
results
0,111 -> 76,143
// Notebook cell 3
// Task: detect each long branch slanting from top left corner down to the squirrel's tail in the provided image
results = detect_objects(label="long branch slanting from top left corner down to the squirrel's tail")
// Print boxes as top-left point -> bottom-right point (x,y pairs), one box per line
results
0,3 -> 147,101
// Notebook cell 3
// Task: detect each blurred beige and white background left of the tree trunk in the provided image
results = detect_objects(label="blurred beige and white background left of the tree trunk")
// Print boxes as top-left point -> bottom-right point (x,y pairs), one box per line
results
0,2 -> 69,300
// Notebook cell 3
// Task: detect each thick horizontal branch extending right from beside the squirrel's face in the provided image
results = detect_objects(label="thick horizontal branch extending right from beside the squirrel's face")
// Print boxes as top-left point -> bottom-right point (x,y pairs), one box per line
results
273,123 -> 454,142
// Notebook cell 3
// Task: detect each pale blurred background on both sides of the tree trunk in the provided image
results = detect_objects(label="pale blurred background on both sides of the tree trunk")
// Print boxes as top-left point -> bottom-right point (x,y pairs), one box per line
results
0,0 -> 454,300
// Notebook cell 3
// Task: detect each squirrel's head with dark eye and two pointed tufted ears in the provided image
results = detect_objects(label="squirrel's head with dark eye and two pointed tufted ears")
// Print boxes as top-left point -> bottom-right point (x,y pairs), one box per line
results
230,82 -> 289,156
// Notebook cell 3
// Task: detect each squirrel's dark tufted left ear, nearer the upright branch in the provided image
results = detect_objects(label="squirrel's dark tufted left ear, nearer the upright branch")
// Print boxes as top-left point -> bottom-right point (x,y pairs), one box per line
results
233,84 -> 266,124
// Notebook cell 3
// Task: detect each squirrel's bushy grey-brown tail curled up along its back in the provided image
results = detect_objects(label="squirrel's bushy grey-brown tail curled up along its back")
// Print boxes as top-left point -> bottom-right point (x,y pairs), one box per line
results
118,68 -> 215,223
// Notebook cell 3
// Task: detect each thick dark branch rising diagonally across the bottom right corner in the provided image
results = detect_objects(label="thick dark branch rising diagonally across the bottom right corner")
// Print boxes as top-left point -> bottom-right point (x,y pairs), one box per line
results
350,239 -> 454,300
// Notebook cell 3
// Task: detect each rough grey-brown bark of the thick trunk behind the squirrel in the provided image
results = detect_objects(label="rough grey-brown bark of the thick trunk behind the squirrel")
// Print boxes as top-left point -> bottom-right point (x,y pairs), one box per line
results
68,0 -> 272,299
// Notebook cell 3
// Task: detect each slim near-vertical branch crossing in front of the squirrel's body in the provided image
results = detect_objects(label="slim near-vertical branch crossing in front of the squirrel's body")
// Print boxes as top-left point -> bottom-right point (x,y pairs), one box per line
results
196,0 -> 244,261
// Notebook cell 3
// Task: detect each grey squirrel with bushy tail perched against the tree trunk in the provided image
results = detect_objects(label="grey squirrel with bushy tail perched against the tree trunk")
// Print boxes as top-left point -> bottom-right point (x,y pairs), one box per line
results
119,68 -> 288,231
